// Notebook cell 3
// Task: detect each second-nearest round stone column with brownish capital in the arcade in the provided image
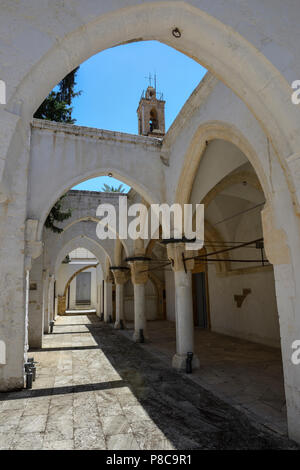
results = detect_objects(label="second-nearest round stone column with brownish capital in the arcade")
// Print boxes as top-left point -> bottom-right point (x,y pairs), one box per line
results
130,260 -> 148,342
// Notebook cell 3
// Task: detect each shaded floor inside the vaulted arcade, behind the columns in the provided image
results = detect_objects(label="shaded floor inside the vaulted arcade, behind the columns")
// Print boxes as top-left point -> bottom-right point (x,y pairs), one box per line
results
122,321 -> 287,435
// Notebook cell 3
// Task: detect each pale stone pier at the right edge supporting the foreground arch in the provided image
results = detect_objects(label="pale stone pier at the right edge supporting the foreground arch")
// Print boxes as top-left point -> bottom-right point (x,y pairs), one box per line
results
262,201 -> 300,443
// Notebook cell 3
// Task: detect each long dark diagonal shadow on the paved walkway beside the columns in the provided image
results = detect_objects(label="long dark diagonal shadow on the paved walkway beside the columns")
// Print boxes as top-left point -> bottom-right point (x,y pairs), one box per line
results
82,316 -> 298,449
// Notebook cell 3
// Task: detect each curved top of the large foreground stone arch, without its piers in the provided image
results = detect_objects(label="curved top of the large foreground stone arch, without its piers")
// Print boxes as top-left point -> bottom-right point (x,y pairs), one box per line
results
9,1 -> 299,171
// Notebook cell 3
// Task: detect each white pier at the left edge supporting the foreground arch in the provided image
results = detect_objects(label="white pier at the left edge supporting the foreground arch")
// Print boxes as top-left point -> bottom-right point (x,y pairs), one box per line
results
0,119 -> 31,392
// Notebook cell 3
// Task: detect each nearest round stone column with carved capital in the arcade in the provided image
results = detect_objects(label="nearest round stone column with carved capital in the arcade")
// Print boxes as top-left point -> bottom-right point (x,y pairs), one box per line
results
168,243 -> 199,369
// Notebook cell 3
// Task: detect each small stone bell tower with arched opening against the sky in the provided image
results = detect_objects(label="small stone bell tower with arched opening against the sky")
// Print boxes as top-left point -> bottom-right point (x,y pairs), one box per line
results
137,80 -> 166,137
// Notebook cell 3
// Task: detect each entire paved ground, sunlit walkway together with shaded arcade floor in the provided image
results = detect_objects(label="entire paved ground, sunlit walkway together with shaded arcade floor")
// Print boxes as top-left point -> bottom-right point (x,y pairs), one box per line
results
0,314 -> 296,450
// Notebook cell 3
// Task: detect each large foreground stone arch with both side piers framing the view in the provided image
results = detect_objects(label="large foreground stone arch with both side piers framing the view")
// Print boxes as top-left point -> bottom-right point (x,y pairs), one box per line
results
0,0 -> 300,439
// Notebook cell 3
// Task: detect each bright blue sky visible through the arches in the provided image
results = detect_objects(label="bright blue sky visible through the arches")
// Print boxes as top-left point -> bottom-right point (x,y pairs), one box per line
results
73,41 -> 206,191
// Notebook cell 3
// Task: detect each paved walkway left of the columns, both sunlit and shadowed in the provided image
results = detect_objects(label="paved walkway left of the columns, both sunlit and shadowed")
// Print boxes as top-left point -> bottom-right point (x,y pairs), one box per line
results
0,315 -> 295,450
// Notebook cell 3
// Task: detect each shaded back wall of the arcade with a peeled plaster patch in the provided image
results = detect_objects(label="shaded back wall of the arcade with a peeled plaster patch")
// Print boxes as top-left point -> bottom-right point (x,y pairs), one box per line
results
208,265 -> 280,347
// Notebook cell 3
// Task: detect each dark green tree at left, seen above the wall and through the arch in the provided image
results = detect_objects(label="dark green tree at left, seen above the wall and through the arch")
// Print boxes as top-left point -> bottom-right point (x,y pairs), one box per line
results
37,67 -> 81,233
